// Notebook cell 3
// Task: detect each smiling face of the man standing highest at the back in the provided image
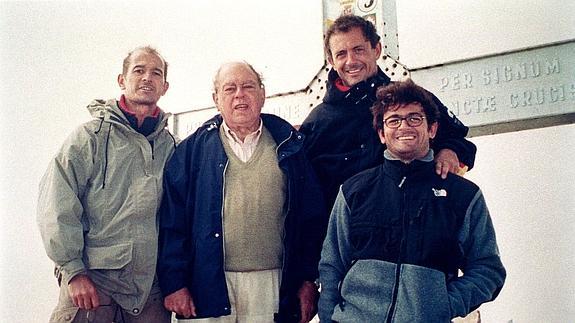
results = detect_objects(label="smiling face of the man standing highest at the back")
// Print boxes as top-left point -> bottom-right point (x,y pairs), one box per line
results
328,27 -> 381,86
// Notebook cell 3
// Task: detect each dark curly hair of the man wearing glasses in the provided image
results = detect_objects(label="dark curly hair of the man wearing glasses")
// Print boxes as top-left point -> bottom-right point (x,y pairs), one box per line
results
371,79 -> 439,131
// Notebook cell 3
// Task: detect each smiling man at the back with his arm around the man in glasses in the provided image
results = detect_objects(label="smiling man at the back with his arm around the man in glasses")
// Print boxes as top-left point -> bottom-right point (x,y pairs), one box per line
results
299,15 -> 476,213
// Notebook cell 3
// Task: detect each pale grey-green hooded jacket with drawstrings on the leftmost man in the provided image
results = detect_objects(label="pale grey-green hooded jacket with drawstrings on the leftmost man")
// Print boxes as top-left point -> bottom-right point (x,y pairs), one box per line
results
37,99 -> 175,313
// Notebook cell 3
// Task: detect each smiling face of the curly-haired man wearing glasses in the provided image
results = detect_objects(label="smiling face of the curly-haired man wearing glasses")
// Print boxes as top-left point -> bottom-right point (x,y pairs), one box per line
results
378,103 -> 437,163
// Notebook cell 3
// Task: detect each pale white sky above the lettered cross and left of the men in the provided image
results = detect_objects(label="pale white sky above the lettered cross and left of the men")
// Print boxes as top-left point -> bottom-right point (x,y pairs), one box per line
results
0,0 -> 575,322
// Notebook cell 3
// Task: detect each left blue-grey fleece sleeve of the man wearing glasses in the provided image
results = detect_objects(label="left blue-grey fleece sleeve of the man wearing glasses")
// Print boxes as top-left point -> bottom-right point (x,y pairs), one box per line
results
318,188 -> 351,322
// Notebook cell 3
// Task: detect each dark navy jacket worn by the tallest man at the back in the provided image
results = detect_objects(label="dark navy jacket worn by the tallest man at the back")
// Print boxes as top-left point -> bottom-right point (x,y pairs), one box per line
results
299,69 -> 476,209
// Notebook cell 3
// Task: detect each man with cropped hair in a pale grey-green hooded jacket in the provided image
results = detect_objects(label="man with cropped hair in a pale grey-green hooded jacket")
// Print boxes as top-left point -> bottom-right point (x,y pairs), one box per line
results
37,47 -> 175,322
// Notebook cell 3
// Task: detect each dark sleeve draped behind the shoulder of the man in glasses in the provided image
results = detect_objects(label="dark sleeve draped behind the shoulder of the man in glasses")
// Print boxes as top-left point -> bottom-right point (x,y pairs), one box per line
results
428,92 -> 477,169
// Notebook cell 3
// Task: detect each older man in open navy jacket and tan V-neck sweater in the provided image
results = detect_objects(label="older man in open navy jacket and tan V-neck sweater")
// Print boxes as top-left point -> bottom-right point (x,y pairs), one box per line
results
158,62 -> 326,323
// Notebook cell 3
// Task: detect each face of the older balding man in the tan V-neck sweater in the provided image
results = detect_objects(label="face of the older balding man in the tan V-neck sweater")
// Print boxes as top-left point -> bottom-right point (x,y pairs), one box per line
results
212,63 -> 265,132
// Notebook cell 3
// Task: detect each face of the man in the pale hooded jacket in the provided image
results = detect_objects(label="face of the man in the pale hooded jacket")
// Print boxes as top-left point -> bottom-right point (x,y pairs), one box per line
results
118,50 -> 169,107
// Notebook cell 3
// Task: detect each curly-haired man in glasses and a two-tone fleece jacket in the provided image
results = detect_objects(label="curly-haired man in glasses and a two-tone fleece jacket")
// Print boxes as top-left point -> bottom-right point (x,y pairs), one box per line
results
319,80 -> 506,322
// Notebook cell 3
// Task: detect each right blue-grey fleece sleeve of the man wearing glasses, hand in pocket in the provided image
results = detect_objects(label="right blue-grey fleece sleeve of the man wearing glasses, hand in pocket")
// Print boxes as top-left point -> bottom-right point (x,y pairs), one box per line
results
447,190 -> 506,317
